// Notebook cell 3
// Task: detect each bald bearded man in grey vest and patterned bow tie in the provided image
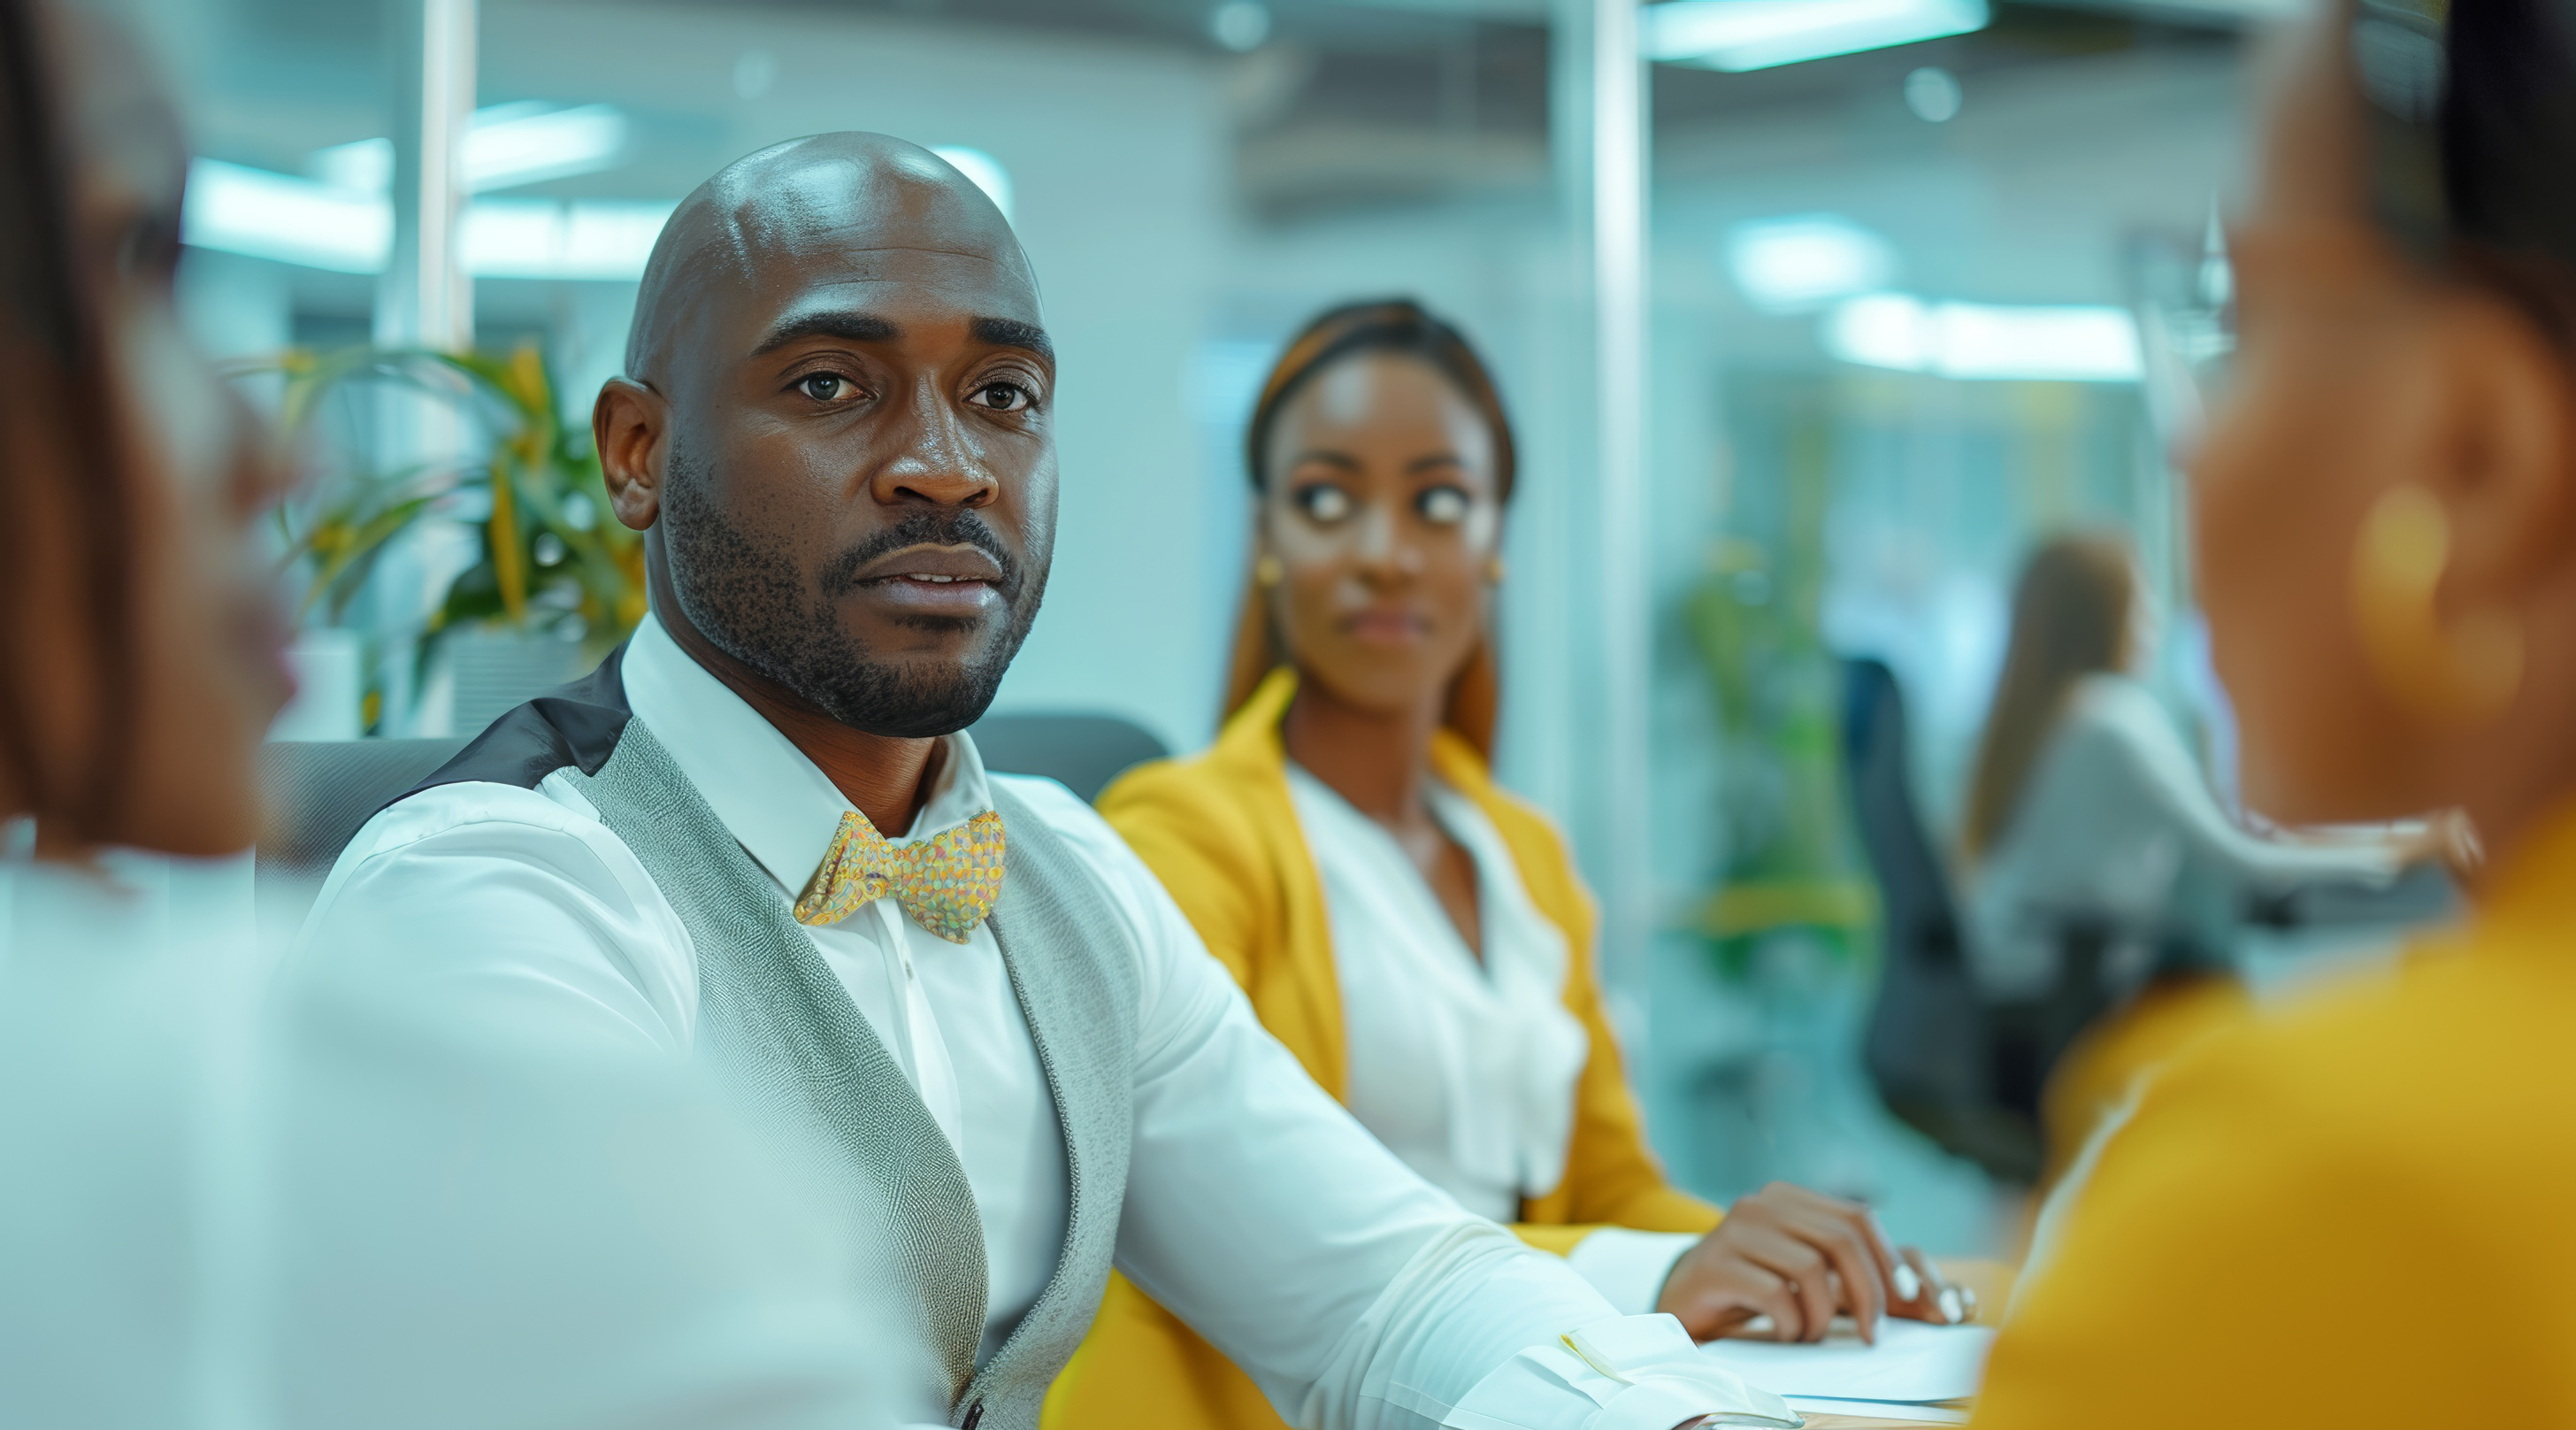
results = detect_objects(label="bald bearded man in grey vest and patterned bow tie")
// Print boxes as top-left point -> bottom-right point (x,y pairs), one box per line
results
292,134 -> 1790,1430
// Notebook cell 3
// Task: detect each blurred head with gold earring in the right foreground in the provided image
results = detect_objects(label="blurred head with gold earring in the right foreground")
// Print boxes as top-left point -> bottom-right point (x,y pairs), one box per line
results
2192,0 -> 2576,853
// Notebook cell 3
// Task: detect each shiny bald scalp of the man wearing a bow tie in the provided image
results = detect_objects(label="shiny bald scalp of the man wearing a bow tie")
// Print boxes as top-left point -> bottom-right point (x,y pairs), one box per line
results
626,131 -> 1039,387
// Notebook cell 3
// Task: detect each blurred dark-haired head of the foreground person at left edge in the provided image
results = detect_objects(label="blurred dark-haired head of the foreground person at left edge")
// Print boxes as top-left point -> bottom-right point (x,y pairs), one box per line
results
0,0 -> 288,856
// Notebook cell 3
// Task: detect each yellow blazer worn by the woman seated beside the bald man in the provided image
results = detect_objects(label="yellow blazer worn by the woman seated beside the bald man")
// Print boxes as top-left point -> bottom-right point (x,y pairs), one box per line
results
1046,670 -> 1721,1430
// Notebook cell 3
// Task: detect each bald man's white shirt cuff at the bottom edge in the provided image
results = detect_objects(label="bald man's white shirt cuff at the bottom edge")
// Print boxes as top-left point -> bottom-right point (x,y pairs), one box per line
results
1422,1317 -> 1798,1430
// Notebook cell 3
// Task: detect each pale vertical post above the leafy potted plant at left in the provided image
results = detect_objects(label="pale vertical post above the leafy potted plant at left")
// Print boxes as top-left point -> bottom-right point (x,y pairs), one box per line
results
376,0 -> 479,348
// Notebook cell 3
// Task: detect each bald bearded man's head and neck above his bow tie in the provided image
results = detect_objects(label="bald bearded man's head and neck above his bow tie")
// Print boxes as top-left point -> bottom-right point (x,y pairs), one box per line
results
593,134 -> 1056,827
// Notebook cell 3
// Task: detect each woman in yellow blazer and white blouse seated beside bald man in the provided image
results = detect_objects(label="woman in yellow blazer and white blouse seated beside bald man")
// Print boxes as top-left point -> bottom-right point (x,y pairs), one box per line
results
1048,299 -> 1966,1430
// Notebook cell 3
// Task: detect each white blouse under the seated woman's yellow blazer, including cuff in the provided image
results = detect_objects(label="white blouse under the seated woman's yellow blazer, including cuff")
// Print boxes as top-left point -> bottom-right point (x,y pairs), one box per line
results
1288,763 -> 1698,1314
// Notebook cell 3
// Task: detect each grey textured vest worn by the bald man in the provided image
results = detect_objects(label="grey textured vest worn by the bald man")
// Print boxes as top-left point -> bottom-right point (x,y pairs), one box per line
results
567,719 -> 1138,1430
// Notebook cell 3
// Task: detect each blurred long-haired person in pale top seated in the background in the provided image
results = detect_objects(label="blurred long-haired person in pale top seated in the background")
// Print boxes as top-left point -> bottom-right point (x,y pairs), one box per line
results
1960,534 -> 2416,1170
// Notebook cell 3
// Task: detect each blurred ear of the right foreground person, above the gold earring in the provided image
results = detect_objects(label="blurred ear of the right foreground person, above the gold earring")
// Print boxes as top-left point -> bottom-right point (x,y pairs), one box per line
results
2421,294 -> 2576,605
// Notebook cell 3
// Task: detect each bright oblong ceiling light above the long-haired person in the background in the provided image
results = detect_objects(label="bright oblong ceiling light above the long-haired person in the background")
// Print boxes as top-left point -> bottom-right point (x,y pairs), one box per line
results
1824,294 -> 2143,381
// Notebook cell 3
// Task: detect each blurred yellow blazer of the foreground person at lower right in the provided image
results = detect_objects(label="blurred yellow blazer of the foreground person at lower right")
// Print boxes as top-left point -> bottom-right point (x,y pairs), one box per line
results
1976,809 -> 2576,1430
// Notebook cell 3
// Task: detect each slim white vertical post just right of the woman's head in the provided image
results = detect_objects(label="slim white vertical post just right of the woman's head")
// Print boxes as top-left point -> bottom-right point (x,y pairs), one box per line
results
1590,0 -> 1656,989
